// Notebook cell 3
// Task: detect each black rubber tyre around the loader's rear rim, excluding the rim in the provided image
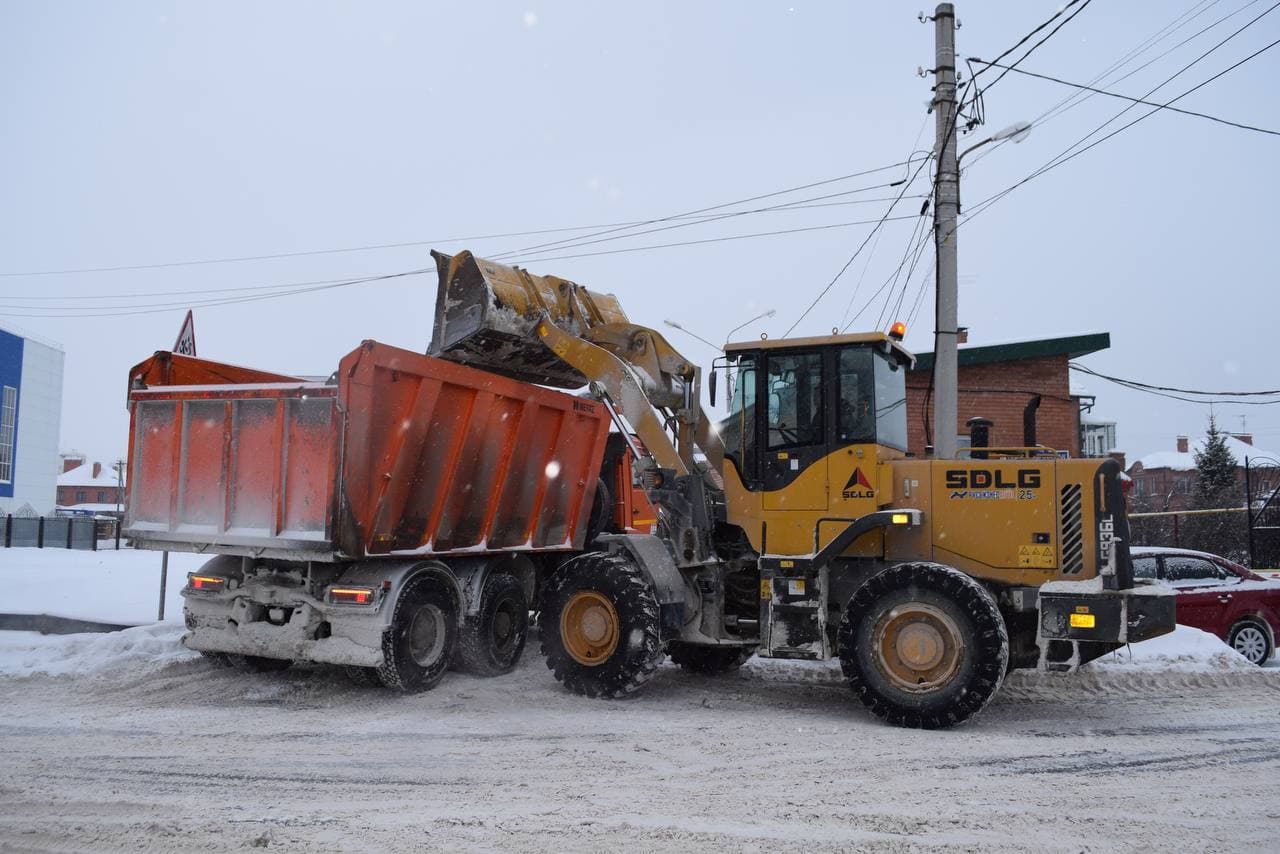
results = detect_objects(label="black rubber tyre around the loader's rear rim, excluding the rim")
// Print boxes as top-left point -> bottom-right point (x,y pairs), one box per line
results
837,562 -> 1009,730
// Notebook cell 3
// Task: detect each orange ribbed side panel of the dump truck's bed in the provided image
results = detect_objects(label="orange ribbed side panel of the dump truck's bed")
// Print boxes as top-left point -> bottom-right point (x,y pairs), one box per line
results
339,342 -> 608,554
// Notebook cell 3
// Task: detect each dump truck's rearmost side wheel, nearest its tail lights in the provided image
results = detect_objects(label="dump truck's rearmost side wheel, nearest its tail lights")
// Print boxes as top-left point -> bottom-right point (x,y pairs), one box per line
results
378,577 -> 458,694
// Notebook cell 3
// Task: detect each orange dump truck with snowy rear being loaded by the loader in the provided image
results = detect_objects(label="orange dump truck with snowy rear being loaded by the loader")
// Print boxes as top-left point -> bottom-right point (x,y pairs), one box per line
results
124,341 -> 619,690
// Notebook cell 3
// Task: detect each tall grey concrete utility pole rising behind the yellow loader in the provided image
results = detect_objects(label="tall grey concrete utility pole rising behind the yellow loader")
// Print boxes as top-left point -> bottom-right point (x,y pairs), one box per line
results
933,3 -> 960,460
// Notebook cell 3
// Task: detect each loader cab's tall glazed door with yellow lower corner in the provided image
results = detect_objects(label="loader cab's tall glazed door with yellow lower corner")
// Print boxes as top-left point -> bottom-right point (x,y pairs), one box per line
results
762,350 -> 827,512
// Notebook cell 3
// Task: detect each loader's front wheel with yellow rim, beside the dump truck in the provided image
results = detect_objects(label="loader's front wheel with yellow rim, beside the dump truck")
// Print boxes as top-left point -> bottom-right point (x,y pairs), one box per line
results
540,552 -> 662,698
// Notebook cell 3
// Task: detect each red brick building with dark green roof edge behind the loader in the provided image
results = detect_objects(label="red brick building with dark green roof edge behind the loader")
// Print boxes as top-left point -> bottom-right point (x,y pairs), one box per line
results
906,332 -> 1111,457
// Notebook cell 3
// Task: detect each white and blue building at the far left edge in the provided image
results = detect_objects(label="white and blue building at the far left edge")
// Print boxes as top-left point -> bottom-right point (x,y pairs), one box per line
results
0,328 -> 64,516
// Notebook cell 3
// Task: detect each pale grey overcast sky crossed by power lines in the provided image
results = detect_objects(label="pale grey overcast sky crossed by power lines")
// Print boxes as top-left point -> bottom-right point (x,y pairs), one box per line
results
0,0 -> 1280,461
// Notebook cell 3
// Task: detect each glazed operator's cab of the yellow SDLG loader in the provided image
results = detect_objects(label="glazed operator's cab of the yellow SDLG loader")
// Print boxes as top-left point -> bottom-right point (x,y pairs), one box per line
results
719,333 -> 914,494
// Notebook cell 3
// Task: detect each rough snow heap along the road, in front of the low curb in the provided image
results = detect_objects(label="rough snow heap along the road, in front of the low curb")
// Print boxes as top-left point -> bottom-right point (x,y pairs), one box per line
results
0,622 -> 200,676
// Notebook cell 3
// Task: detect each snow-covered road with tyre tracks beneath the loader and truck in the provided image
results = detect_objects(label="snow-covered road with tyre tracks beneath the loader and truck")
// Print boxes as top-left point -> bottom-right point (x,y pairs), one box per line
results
0,626 -> 1280,851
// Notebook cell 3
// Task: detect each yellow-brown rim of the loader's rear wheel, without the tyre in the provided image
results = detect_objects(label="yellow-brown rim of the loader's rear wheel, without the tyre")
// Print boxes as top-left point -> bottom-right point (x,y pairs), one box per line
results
872,602 -> 964,694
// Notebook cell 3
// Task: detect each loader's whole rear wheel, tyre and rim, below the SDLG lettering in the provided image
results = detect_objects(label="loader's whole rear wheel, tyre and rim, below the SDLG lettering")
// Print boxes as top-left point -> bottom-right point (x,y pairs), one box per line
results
837,563 -> 1009,730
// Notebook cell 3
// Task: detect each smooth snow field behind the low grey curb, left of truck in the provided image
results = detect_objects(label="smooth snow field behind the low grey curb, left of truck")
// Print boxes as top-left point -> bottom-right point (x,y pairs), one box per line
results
0,548 -> 209,624
